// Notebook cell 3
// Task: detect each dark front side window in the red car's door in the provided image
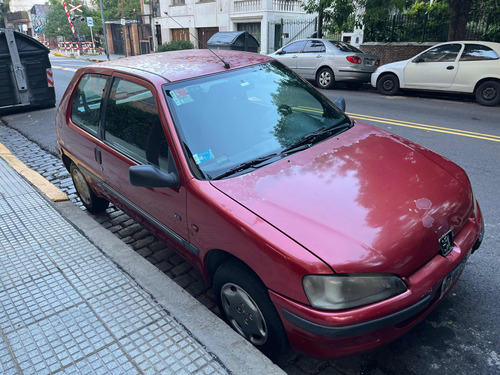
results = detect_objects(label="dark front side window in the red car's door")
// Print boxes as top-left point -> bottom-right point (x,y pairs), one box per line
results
104,78 -> 168,171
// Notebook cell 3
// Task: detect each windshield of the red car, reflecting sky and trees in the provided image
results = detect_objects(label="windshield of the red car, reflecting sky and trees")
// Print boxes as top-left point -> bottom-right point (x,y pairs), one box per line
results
164,62 -> 351,179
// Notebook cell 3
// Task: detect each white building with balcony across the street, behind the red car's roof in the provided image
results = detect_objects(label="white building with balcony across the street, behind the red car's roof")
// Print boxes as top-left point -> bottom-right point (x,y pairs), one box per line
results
144,0 -> 316,54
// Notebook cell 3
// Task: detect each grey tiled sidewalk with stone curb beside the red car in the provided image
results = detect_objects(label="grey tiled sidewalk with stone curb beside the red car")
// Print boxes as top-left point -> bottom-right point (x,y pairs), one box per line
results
0,144 -> 283,374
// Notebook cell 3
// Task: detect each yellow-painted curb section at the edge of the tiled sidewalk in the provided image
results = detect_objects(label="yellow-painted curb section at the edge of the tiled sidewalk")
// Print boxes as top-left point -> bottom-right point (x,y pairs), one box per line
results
0,143 -> 69,202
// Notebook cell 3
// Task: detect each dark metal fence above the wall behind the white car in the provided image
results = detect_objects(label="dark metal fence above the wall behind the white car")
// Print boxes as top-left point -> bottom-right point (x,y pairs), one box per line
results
364,13 -> 500,42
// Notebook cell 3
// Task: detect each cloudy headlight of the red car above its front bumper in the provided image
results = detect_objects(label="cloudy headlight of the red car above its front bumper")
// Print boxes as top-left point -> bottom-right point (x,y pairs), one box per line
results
302,274 -> 406,310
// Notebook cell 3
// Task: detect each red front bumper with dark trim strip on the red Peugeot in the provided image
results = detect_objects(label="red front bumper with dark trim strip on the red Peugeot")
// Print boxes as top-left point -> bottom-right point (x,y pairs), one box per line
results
270,203 -> 484,359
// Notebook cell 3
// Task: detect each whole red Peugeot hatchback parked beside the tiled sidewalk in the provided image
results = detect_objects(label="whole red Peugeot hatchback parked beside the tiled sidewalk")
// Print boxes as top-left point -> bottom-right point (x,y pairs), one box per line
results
56,50 -> 484,358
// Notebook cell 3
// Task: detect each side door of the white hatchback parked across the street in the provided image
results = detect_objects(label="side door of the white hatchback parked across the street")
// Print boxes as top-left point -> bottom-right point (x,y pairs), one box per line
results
404,43 -> 462,90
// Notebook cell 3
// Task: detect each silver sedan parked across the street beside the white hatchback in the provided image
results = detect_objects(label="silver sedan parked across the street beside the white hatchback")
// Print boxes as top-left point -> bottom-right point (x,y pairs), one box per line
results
270,39 -> 380,89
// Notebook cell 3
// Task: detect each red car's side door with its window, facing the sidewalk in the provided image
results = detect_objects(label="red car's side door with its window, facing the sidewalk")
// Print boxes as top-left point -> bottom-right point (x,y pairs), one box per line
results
100,74 -> 196,258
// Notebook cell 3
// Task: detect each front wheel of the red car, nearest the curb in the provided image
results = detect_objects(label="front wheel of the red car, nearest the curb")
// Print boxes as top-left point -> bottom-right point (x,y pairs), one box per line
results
213,260 -> 288,358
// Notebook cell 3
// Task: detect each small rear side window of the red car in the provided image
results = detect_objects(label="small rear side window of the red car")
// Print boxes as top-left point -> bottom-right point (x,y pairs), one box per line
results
71,74 -> 108,135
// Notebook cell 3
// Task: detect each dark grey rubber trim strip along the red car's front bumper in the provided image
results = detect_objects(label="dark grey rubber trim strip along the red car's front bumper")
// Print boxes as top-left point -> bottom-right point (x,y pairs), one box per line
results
283,295 -> 431,337
